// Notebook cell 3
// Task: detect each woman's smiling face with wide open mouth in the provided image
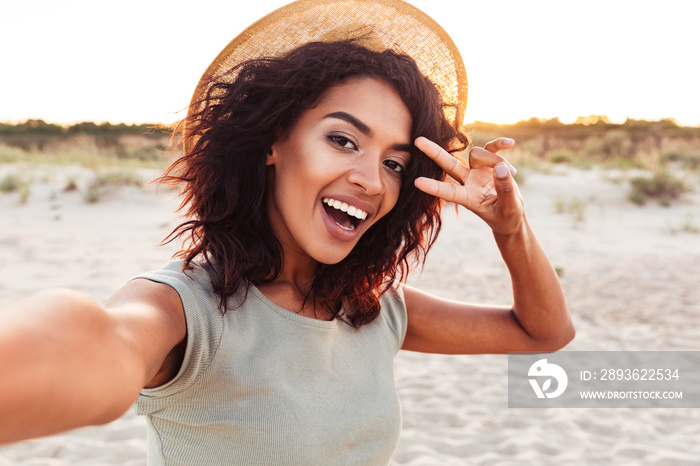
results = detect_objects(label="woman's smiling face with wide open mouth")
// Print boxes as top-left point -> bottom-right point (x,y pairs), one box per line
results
267,77 -> 412,264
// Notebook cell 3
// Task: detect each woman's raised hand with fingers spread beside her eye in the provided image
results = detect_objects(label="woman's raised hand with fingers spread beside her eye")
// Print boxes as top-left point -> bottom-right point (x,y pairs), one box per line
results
415,136 -> 524,235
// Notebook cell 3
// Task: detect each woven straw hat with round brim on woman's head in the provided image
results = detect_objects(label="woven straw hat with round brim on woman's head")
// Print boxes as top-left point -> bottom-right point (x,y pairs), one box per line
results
189,0 -> 467,124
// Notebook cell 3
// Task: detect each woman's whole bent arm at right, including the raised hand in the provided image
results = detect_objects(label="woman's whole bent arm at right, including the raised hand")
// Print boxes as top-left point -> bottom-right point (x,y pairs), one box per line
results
403,138 -> 574,354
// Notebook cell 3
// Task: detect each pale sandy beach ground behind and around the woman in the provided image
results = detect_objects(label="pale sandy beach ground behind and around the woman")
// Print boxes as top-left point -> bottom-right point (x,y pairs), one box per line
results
0,166 -> 700,466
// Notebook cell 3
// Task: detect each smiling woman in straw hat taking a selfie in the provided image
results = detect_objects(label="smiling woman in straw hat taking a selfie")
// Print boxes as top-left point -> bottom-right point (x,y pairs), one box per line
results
0,0 -> 573,464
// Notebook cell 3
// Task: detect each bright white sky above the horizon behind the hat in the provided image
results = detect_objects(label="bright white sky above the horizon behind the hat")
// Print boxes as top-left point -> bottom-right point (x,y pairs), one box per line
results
0,0 -> 700,126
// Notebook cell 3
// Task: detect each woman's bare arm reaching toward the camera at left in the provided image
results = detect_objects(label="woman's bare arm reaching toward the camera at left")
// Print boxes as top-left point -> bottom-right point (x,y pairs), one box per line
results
0,280 -> 186,444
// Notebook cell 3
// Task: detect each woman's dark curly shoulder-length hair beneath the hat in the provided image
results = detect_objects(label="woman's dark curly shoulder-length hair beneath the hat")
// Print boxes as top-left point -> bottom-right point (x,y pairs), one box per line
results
161,41 -> 468,327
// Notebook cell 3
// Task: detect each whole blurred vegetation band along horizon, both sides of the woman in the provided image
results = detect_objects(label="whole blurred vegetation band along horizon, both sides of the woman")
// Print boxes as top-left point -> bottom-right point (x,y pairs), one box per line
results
0,115 -> 700,206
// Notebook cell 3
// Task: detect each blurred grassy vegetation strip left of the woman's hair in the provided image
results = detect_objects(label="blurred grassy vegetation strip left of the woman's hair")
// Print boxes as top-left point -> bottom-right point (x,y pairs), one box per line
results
0,120 -> 174,204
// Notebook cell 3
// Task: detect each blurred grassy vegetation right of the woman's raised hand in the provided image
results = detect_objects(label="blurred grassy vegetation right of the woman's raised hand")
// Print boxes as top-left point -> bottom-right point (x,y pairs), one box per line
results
466,115 -> 700,205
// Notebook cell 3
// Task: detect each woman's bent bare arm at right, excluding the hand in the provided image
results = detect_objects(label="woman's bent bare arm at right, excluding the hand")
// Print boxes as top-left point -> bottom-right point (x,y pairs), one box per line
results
403,218 -> 574,354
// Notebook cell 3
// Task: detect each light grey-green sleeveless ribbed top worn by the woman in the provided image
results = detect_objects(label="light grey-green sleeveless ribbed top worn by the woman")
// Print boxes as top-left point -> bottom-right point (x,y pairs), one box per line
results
136,261 -> 406,466
